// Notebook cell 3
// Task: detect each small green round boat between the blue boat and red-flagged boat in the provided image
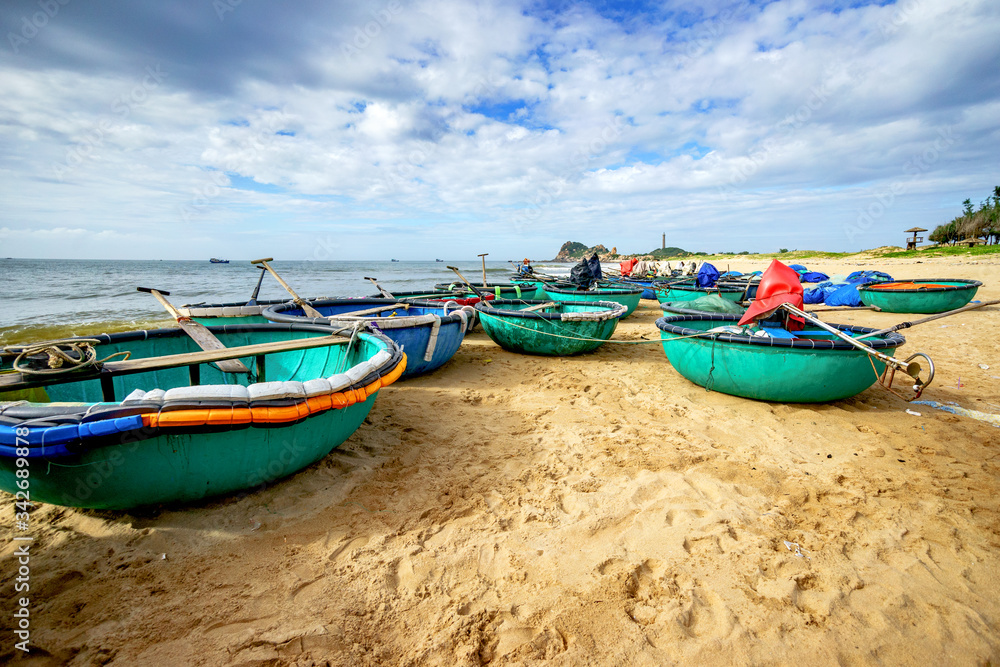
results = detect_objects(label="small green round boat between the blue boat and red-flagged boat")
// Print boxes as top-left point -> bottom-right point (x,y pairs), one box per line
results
476,299 -> 626,357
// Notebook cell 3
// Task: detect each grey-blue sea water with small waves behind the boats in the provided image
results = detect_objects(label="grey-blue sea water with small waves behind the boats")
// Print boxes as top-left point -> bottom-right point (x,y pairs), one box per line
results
0,259 -> 572,344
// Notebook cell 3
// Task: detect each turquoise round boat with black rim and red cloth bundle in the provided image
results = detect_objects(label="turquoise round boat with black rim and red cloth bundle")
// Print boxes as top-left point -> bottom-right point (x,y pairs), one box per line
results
656,314 -> 906,403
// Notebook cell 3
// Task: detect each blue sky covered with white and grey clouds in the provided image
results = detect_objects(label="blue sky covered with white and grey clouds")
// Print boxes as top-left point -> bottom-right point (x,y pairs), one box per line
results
0,0 -> 1000,260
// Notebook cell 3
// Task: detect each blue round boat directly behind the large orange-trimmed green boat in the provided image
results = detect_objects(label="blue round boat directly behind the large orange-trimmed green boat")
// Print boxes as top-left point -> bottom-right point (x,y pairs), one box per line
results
264,299 -> 475,379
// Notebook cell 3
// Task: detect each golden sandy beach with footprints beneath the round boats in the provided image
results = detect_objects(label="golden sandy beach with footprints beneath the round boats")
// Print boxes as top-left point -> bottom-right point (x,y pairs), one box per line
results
0,256 -> 1000,667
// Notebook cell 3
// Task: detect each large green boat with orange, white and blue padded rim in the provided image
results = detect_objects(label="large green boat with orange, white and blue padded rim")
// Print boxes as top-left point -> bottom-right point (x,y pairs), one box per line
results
0,324 -> 406,509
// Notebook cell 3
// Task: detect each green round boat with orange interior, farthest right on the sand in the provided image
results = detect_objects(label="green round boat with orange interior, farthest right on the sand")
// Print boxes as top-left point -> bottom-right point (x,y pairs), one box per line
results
858,278 -> 983,314
